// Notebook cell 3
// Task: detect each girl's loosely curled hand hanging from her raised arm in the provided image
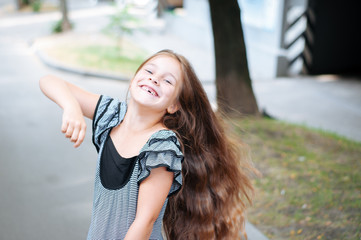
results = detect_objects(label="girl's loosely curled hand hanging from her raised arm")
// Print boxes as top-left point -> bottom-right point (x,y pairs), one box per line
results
61,109 -> 86,148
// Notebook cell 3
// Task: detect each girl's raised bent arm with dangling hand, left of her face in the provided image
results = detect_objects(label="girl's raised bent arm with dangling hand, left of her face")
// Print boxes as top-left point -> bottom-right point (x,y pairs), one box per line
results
39,75 -> 99,147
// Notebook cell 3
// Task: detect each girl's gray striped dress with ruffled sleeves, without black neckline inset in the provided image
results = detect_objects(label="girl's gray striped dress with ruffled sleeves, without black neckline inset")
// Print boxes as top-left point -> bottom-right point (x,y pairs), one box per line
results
87,96 -> 183,240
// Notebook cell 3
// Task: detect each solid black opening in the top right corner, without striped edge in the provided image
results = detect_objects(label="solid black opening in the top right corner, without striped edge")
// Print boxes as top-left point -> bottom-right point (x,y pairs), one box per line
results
302,0 -> 361,75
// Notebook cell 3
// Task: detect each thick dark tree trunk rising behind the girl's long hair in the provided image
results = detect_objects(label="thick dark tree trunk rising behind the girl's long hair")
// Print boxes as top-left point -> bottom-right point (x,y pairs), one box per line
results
209,0 -> 259,116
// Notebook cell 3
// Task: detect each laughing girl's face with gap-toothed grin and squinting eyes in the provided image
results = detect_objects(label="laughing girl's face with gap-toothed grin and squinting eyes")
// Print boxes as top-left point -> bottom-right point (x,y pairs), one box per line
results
130,55 -> 182,114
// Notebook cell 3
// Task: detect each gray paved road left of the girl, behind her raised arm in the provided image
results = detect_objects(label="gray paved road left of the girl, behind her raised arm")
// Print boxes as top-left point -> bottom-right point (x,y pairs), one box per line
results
0,32 -> 127,240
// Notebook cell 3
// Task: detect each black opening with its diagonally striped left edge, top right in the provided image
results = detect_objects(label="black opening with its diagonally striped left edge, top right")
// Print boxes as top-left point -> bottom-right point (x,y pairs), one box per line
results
276,0 -> 361,76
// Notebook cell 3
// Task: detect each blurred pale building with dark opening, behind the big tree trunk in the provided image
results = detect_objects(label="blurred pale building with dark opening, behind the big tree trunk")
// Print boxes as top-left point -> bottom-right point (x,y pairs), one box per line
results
172,0 -> 361,78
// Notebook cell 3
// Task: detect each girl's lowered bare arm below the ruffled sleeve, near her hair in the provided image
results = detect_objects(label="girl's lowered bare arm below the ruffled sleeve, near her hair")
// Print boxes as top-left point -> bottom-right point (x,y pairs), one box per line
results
125,167 -> 173,240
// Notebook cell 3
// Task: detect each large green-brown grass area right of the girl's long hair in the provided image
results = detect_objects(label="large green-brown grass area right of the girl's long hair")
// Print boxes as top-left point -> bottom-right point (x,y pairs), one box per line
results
233,119 -> 361,240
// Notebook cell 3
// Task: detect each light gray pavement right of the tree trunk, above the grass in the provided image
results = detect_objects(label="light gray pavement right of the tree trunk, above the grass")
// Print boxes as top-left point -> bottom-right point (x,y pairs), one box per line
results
254,76 -> 361,142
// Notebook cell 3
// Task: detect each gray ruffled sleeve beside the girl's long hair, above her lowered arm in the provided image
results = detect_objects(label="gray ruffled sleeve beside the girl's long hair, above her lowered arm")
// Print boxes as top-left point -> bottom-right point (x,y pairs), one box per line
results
138,130 -> 183,197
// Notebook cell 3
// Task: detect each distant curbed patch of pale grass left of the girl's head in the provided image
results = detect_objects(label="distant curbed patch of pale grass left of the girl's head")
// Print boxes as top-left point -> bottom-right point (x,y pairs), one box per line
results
47,41 -> 148,78
